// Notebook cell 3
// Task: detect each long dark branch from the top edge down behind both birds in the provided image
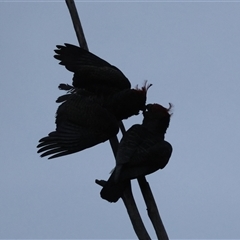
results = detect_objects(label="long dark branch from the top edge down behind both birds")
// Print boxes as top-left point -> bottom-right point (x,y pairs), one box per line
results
66,0 -> 151,240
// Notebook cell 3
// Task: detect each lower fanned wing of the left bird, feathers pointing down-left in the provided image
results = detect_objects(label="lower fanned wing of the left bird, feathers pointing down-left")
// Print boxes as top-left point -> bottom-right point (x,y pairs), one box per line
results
37,90 -> 119,159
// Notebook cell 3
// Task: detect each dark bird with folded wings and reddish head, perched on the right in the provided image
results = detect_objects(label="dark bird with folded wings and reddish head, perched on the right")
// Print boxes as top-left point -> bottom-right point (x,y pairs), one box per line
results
100,104 -> 172,202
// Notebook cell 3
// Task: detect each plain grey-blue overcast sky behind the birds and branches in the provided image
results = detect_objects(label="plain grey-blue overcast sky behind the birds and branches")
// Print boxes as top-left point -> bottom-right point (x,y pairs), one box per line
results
0,1 -> 240,239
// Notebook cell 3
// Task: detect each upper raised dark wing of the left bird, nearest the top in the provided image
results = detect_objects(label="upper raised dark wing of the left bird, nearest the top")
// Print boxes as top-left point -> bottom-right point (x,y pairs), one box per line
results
54,43 -> 131,96
